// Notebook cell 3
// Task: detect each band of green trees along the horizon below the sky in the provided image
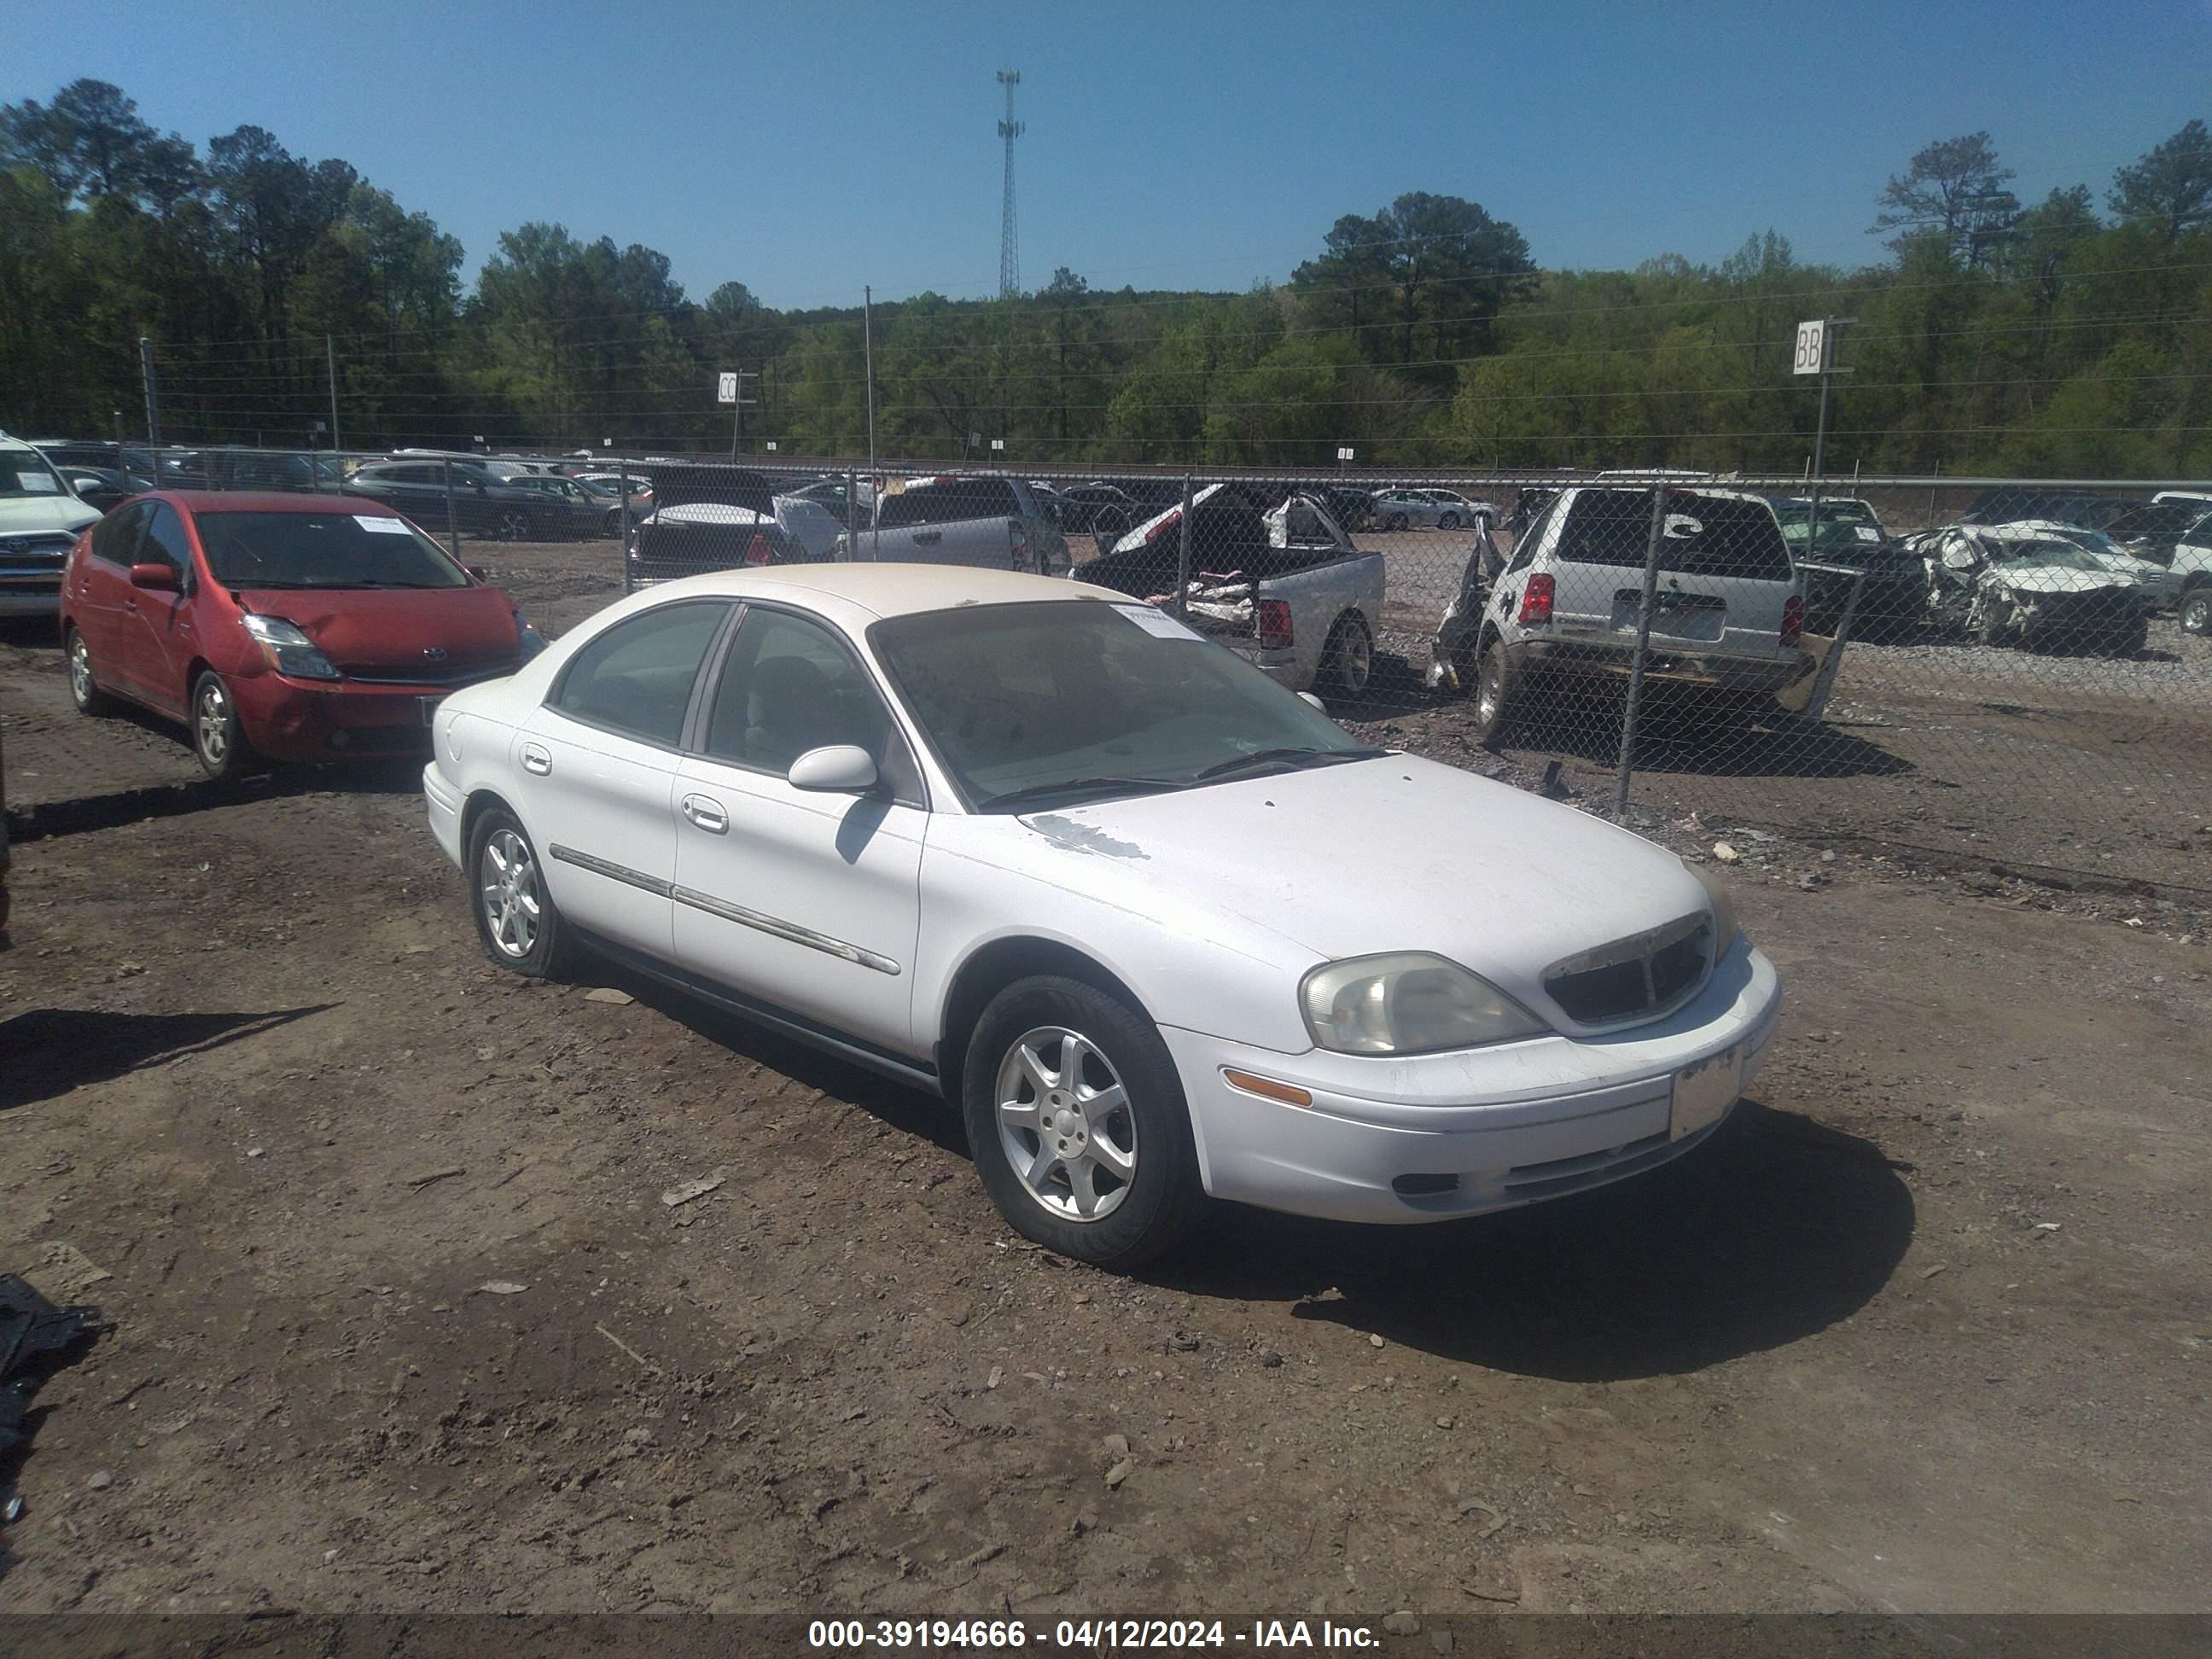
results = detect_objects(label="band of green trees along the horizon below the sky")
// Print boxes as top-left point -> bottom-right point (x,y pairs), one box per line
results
0,82 -> 2212,475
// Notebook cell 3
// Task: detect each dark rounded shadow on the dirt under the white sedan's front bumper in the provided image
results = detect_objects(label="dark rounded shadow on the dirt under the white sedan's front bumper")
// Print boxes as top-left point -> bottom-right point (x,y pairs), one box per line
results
1146,1102 -> 1913,1382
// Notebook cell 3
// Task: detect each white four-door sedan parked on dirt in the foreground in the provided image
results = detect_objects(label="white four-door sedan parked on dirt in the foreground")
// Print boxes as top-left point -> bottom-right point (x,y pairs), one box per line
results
422,564 -> 1781,1266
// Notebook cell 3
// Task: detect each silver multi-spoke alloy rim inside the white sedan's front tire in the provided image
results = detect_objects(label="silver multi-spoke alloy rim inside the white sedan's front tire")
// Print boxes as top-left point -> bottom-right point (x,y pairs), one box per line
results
995,1027 -> 1137,1221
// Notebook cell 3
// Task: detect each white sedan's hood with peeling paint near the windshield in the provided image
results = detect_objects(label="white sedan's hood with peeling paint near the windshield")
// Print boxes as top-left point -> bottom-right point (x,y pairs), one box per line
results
1024,754 -> 1708,1000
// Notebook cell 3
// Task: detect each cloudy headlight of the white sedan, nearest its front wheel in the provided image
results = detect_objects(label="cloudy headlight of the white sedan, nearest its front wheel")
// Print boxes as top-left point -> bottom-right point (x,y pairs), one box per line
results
1299,952 -> 1548,1055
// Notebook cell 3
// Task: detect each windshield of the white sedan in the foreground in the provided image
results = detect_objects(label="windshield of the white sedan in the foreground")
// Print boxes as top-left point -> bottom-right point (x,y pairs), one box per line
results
870,599 -> 1380,812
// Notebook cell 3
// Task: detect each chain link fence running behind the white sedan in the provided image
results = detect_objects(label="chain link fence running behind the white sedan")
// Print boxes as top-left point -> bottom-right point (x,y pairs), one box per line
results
21,442 -> 2212,892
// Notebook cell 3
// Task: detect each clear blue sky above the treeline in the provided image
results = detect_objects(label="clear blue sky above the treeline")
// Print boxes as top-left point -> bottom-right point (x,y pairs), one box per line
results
0,0 -> 2212,307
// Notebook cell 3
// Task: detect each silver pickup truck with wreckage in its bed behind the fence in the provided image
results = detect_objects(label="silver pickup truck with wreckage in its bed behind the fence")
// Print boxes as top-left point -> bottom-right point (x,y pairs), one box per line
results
1075,485 -> 1382,696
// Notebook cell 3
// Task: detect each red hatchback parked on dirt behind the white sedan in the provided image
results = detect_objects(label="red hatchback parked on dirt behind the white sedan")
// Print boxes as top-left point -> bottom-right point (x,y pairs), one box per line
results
62,491 -> 544,778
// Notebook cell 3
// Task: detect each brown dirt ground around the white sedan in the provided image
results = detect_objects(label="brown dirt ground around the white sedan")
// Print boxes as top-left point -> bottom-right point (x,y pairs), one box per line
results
0,535 -> 2212,1615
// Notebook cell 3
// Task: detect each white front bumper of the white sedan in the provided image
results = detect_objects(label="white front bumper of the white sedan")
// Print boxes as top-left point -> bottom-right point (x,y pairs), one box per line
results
1161,942 -> 1781,1223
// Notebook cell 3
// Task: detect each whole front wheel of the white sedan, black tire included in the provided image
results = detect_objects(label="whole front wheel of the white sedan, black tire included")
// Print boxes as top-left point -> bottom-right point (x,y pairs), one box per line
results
960,975 -> 1206,1267
